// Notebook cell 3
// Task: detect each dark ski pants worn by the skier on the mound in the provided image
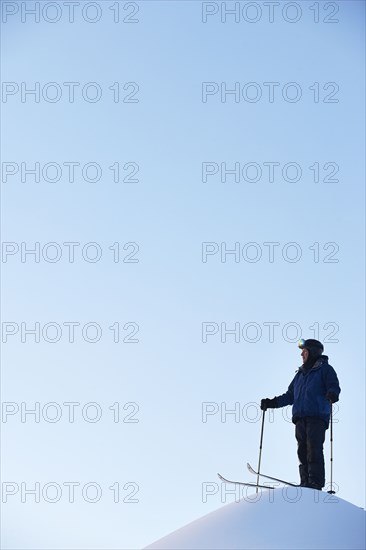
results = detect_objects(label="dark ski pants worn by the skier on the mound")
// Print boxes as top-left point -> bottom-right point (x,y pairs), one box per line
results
295,416 -> 328,489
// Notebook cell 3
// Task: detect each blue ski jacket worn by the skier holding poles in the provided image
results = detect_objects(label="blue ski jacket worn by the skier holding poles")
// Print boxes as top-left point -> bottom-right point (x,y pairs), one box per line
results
275,355 -> 341,426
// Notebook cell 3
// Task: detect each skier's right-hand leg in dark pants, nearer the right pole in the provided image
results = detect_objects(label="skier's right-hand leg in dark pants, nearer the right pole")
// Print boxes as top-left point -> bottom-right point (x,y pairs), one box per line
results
306,417 -> 327,489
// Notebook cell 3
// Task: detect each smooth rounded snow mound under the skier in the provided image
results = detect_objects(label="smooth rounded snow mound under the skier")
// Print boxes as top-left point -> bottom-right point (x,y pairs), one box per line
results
147,487 -> 366,550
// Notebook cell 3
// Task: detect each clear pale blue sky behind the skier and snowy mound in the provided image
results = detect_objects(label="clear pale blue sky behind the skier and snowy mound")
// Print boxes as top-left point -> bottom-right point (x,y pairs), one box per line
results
1,0 -> 365,549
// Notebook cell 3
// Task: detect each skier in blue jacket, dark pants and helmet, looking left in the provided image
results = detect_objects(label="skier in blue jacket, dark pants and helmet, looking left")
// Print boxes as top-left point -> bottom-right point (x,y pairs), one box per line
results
261,339 -> 341,490
